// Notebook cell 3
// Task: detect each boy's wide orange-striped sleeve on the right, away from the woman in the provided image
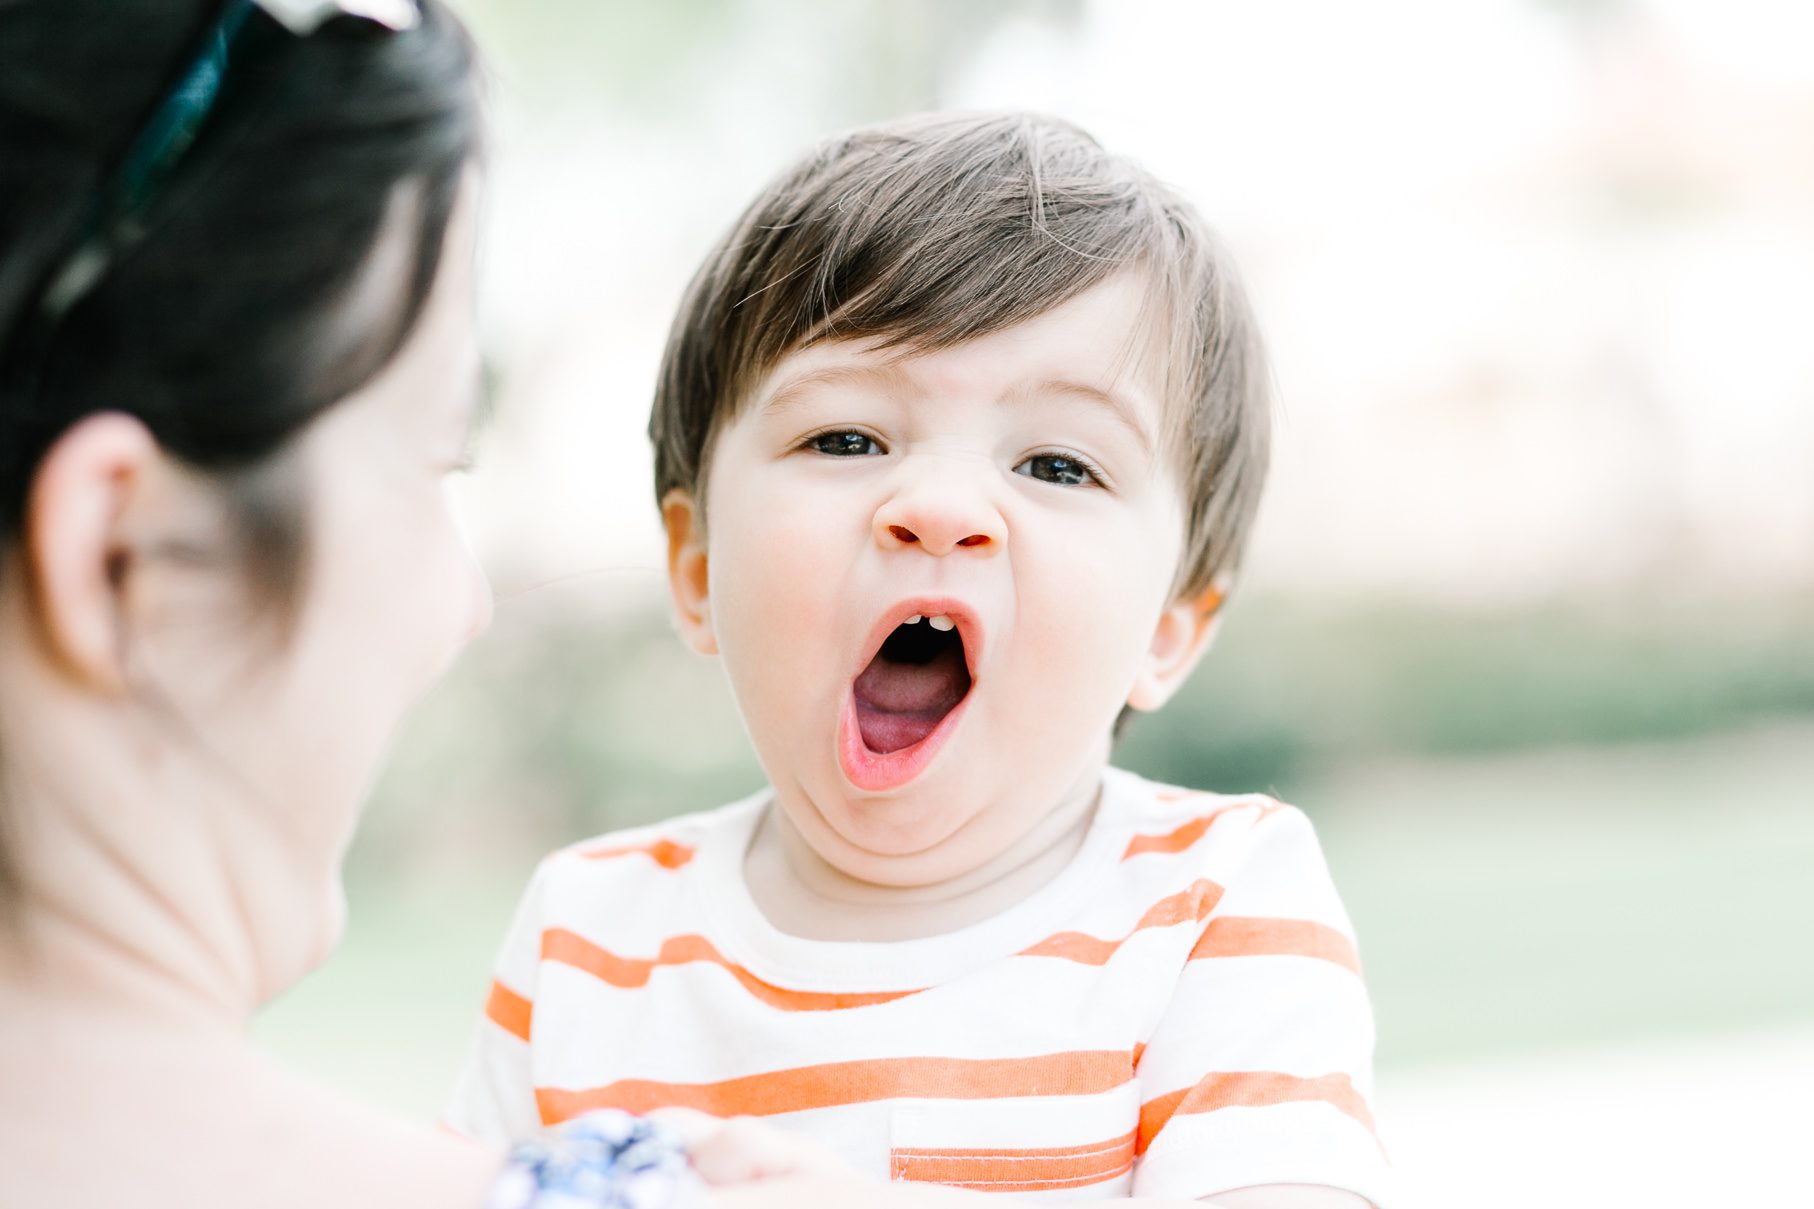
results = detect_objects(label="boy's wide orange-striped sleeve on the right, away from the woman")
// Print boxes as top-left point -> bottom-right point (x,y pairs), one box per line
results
1132,802 -> 1395,1209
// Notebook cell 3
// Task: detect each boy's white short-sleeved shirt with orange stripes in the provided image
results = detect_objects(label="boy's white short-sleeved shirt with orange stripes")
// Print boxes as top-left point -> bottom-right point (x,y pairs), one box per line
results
448,770 -> 1391,1205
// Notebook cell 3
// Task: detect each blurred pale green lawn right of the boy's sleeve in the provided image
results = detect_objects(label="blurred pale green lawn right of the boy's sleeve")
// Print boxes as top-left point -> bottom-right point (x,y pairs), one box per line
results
1301,721 -> 1814,1066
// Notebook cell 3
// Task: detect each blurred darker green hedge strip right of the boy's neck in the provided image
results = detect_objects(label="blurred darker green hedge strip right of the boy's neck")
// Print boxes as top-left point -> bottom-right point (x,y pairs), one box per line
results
1117,599 -> 1814,788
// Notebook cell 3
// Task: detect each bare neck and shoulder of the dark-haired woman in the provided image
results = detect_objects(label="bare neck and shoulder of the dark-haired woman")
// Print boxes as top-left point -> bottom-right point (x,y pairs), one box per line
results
0,602 -> 497,1209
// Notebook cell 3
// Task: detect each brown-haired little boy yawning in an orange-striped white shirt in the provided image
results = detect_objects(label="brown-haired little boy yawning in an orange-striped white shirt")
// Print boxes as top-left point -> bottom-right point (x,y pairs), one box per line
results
448,114 -> 1390,1209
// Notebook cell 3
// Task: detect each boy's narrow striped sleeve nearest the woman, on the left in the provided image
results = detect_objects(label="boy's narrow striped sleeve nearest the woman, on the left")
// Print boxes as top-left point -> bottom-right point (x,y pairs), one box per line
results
443,860 -> 550,1145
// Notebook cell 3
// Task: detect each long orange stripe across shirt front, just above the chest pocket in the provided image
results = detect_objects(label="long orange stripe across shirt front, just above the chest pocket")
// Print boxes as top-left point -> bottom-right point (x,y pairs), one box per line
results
535,1049 -> 1134,1125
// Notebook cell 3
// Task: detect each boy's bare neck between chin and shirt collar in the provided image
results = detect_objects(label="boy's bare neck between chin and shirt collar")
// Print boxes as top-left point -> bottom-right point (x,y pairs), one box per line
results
744,775 -> 1101,942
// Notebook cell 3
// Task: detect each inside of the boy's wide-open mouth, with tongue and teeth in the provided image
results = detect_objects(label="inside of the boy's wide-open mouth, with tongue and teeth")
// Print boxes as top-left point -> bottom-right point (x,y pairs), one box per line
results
853,615 -> 970,755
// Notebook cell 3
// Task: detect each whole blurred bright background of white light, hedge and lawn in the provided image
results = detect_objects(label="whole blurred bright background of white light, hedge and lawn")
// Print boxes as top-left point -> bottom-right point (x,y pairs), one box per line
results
258,9 -> 1814,1204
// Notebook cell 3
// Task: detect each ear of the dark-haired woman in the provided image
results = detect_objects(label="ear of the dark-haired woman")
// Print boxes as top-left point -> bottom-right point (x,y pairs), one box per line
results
22,412 -> 163,692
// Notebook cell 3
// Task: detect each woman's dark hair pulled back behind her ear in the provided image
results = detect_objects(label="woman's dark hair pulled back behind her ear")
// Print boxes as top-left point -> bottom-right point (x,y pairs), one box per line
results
0,0 -> 479,906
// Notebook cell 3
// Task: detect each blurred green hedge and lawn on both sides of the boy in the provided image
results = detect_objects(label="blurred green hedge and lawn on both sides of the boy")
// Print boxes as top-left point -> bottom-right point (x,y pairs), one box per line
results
259,601 -> 1814,1115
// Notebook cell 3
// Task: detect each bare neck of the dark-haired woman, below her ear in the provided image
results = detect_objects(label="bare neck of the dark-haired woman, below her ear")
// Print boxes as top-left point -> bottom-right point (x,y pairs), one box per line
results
0,624 -> 339,1031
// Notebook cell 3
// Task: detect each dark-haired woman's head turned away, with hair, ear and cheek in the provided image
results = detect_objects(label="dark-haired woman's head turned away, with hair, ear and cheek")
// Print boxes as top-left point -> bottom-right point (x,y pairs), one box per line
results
0,0 -> 486,958
